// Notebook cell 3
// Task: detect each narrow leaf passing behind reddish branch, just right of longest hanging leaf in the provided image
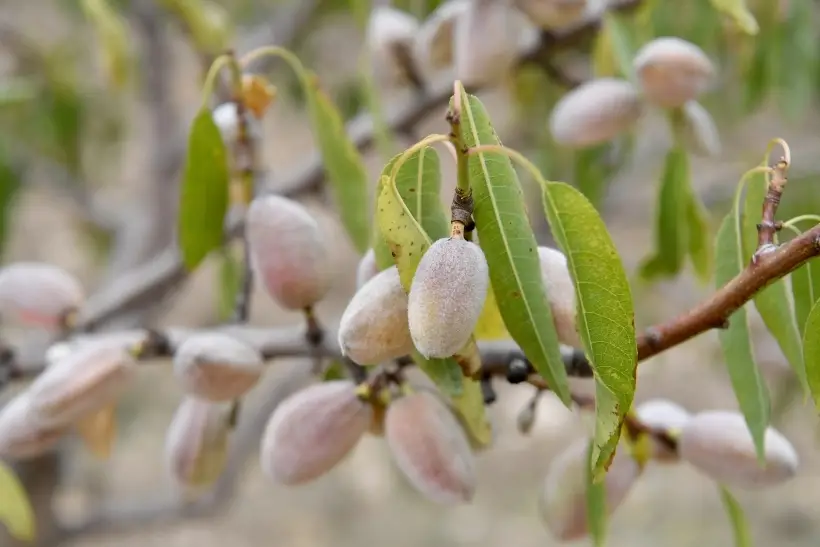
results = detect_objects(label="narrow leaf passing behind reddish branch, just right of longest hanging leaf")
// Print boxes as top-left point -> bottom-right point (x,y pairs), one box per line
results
742,175 -> 808,391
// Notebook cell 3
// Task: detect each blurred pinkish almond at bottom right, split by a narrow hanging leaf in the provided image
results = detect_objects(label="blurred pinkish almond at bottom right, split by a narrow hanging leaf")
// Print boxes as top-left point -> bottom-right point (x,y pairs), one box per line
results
539,439 -> 642,541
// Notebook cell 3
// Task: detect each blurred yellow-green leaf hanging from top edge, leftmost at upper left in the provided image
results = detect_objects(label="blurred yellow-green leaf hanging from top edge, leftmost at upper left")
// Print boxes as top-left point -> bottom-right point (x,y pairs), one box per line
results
81,0 -> 131,88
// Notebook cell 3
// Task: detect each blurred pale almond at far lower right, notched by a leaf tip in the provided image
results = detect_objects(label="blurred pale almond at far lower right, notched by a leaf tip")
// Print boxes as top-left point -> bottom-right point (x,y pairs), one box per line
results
678,410 -> 799,488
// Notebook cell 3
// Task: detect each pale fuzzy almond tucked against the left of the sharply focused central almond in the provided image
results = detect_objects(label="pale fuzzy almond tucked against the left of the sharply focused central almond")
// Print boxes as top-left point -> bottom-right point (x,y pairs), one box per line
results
339,266 -> 413,365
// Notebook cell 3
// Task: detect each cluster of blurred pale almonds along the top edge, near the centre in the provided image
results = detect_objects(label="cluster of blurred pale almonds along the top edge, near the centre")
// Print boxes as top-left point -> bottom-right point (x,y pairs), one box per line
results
367,0 -> 607,88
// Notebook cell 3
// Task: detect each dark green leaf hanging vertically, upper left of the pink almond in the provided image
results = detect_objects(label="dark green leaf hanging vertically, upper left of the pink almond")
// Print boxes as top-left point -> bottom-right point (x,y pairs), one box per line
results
177,108 -> 229,270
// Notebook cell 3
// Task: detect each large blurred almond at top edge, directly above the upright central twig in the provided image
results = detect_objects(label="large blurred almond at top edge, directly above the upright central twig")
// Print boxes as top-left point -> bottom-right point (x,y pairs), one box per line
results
453,0 -> 537,86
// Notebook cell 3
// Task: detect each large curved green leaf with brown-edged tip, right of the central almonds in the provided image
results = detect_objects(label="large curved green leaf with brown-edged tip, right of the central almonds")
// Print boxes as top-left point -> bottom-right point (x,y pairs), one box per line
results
542,182 -> 638,482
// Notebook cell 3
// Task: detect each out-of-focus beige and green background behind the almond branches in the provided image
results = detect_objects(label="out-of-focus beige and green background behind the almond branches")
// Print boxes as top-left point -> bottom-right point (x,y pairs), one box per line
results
0,0 -> 820,547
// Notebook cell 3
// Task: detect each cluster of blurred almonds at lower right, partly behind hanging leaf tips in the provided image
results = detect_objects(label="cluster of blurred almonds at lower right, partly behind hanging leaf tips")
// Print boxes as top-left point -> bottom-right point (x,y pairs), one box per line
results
539,399 -> 799,541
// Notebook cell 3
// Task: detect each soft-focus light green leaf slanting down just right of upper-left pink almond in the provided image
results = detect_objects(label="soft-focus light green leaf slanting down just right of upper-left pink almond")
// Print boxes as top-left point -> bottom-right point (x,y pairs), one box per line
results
302,72 -> 370,253
